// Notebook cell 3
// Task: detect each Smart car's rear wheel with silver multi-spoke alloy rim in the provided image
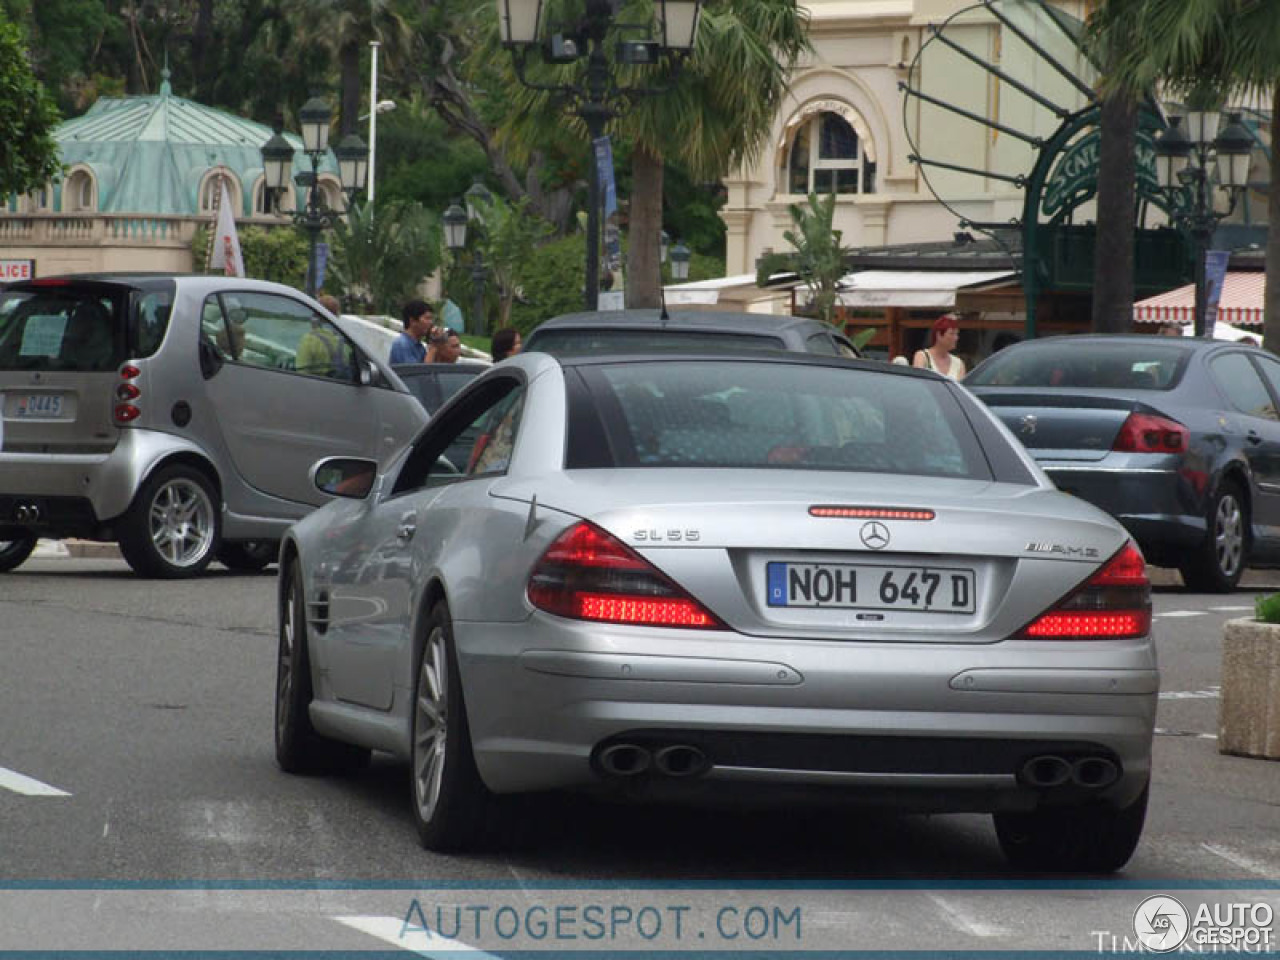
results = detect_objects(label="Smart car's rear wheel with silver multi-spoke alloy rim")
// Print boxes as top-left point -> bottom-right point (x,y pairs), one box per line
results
119,463 -> 221,580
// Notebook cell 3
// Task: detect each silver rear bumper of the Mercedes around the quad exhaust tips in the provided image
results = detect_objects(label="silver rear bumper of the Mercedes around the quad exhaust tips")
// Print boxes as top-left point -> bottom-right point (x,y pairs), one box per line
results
454,614 -> 1158,812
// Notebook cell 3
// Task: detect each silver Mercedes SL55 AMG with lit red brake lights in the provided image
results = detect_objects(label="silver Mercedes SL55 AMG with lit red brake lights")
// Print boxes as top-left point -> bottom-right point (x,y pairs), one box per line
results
275,353 -> 1158,872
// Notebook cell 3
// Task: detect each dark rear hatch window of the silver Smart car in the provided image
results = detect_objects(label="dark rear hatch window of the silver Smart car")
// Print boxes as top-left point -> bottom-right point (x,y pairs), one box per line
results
0,287 -> 128,371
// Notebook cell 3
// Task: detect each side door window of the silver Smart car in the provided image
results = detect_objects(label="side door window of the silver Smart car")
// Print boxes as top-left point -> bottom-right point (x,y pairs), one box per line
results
221,292 -> 356,383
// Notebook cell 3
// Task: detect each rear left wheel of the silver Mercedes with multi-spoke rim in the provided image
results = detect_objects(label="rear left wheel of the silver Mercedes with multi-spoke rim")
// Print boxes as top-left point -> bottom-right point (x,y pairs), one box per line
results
410,600 -> 489,854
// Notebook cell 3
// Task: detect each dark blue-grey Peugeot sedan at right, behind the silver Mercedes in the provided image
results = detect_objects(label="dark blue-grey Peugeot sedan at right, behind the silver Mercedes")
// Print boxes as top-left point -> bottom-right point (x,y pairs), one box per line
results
965,335 -> 1280,593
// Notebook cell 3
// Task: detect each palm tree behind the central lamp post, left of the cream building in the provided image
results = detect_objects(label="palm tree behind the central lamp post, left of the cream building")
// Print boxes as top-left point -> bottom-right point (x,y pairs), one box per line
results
472,0 -> 810,307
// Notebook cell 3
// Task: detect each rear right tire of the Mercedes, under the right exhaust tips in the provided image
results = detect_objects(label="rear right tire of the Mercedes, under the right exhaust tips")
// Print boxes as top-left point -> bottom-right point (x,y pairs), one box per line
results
993,783 -> 1151,873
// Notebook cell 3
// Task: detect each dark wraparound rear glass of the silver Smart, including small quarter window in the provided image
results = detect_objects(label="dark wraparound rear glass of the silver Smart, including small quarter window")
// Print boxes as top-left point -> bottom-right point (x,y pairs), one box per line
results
0,284 -> 173,371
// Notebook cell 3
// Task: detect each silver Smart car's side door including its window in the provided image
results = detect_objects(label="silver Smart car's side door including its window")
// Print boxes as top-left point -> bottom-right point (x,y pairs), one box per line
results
201,291 -> 371,504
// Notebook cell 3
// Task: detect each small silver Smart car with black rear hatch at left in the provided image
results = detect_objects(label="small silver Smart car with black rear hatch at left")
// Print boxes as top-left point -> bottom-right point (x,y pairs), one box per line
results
0,274 -> 426,577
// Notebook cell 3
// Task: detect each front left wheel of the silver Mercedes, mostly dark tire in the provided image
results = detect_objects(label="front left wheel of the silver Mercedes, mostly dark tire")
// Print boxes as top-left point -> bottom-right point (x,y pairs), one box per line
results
274,567 -> 370,773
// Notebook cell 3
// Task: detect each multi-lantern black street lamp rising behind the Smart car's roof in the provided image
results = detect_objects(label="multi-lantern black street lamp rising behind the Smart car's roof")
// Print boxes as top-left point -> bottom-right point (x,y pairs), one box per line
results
262,97 -> 369,297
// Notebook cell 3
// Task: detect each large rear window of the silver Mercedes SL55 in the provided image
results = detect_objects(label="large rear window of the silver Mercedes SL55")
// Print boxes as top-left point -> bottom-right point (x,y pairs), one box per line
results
567,360 -> 992,480
